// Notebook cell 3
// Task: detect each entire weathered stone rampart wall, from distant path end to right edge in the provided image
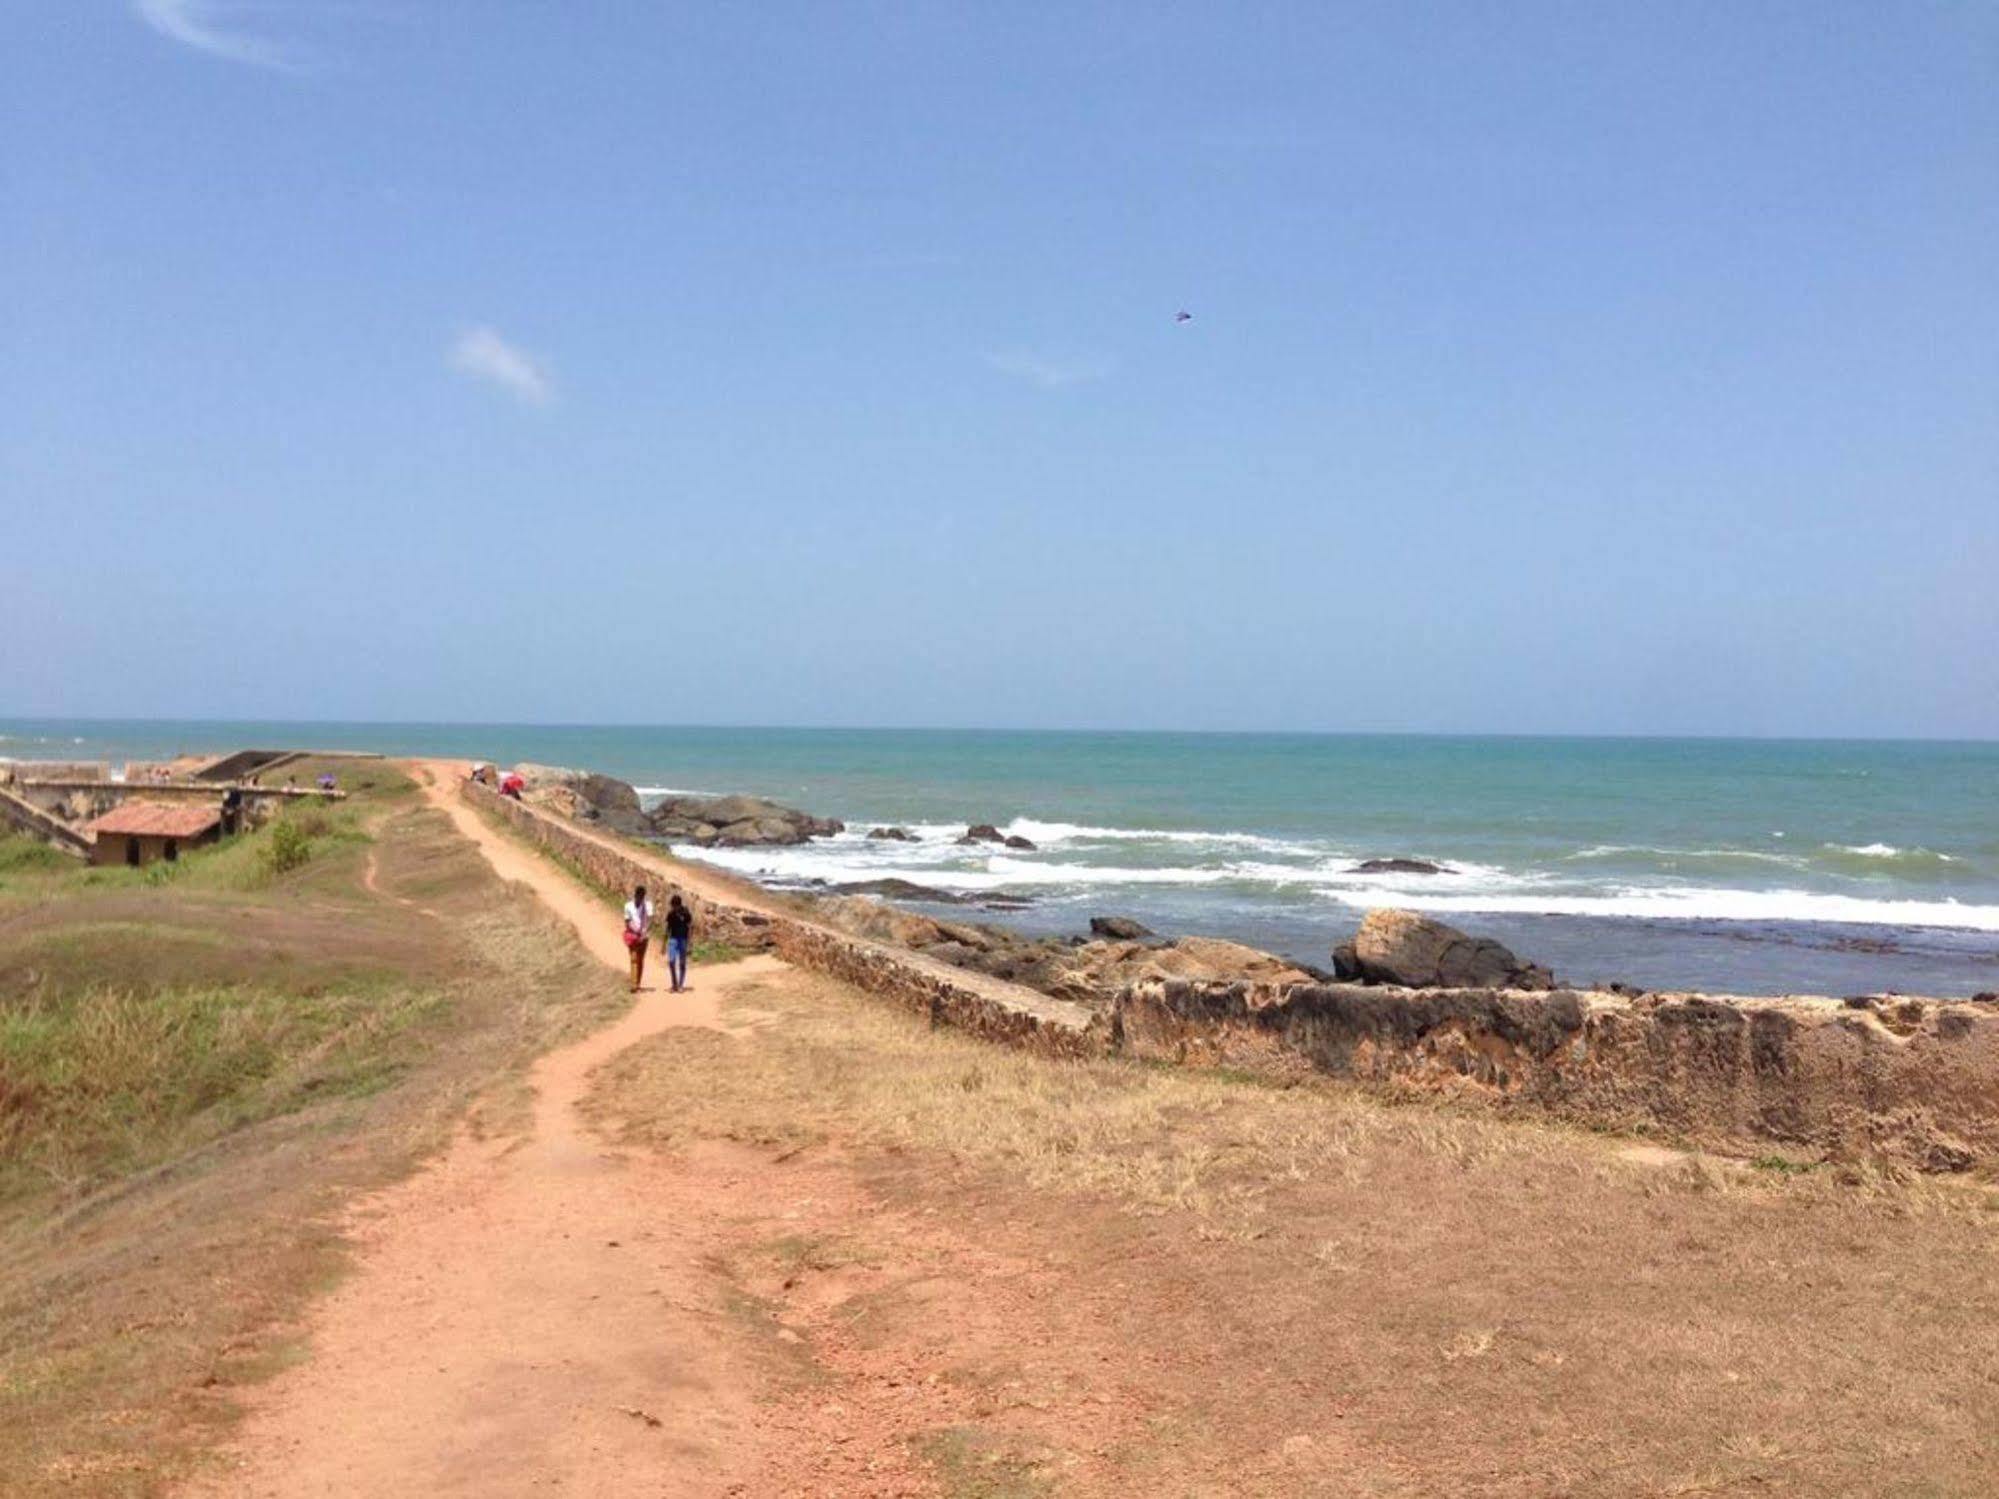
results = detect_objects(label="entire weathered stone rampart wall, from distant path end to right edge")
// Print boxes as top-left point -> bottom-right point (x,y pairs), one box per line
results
466,781 -> 1999,1171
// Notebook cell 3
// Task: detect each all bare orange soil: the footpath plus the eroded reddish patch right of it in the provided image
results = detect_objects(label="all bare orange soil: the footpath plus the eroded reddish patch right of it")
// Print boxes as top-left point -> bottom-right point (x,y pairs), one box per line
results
192,773 -> 1121,1497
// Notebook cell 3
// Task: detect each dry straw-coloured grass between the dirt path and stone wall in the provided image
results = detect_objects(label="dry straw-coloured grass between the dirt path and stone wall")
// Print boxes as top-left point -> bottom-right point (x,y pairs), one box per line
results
594,975 -> 1999,1495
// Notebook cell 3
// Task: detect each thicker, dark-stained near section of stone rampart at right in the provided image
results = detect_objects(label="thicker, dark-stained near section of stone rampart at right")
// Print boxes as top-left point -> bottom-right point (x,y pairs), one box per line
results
1113,979 -> 1999,1171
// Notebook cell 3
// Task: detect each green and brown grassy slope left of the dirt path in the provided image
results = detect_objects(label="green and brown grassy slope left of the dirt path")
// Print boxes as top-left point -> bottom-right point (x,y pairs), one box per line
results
0,765 -> 616,1495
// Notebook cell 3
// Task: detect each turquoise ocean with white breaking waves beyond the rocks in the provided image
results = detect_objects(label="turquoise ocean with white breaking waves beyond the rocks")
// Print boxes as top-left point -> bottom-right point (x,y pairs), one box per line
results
0,720 -> 1999,995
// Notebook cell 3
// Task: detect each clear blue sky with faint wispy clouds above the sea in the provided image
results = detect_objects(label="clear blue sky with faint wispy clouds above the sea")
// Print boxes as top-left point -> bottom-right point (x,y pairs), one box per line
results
0,0 -> 1999,738
